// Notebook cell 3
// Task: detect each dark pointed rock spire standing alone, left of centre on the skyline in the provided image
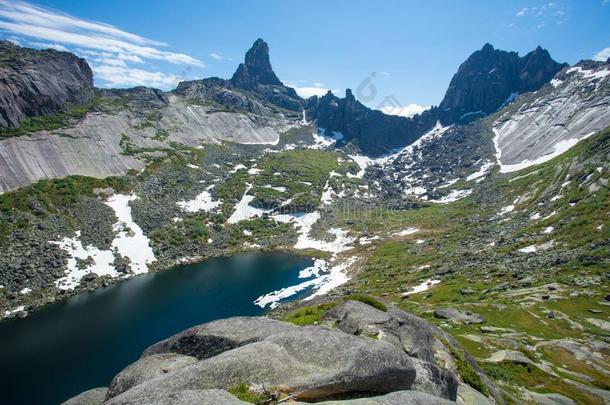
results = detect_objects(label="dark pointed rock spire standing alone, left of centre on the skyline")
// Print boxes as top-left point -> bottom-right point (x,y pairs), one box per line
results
231,38 -> 283,89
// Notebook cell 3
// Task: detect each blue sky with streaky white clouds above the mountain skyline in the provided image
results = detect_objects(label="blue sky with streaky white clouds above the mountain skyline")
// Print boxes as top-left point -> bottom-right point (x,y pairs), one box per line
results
0,0 -> 610,115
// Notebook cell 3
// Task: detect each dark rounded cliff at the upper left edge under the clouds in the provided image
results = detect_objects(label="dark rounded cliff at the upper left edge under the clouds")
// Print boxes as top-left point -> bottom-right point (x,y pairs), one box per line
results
0,41 -> 93,128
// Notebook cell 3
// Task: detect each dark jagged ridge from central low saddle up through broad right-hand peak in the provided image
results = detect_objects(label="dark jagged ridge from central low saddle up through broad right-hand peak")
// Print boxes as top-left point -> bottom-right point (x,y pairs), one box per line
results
307,44 -> 567,156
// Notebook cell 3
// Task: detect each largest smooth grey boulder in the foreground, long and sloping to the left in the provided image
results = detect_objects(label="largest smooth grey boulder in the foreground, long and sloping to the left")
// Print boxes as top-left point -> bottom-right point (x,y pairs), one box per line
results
108,326 -> 415,403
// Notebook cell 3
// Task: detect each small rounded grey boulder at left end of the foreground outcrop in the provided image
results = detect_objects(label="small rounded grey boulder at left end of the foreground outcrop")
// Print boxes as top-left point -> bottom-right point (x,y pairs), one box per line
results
107,353 -> 197,398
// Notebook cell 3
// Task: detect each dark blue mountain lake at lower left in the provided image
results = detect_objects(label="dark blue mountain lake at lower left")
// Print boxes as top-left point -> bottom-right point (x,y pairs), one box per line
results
0,254 -> 311,404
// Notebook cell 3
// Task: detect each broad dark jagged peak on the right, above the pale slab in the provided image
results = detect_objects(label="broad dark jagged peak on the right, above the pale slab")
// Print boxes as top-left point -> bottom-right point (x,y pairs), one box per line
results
439,44 -> 566,122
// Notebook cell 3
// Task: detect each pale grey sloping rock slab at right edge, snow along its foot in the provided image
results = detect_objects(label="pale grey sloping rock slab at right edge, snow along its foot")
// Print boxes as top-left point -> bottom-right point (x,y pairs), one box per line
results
493,61 -> 610,172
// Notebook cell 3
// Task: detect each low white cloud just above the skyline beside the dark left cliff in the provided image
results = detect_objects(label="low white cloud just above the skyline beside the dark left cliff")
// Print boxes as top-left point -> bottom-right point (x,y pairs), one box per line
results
94,65 -> 183,89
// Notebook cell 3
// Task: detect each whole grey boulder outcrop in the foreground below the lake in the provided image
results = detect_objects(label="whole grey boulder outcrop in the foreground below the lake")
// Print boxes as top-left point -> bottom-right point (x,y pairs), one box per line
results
66,301 -> 496,405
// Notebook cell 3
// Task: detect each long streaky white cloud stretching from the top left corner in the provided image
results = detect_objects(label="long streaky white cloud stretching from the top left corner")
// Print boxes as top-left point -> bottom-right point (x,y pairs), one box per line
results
0,0 -> 204,66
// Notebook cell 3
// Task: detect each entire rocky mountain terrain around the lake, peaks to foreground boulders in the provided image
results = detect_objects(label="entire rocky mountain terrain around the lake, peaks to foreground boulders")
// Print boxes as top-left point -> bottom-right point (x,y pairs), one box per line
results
0,39 -> 610,404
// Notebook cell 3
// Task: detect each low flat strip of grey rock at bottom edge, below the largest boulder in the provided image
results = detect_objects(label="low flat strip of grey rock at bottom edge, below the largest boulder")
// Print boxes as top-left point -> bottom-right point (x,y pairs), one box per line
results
106,389 -> 247,405
